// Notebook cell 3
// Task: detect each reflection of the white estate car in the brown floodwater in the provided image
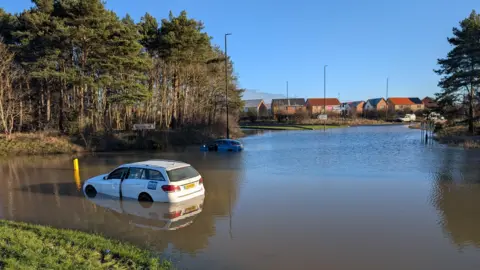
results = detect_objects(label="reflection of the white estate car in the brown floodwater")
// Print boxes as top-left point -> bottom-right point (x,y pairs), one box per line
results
86,194 -> 205,231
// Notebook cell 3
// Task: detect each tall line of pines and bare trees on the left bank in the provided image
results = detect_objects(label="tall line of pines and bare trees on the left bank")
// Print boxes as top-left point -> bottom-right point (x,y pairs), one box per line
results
0,0 -> 242,134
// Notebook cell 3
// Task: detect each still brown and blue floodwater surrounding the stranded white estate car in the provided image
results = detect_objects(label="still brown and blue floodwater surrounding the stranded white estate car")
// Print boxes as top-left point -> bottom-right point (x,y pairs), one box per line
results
0,126 -> 480,270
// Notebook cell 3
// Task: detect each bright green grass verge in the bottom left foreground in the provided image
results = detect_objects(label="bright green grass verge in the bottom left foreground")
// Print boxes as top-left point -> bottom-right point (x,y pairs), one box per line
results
0,220 -> 171,269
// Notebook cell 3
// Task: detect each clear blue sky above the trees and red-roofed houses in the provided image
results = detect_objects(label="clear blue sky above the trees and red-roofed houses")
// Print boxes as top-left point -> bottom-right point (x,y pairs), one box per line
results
0,0 -> 480,101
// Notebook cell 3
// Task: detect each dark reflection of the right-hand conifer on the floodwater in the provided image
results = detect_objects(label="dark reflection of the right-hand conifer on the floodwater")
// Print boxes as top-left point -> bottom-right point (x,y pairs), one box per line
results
432,149 -> 480,249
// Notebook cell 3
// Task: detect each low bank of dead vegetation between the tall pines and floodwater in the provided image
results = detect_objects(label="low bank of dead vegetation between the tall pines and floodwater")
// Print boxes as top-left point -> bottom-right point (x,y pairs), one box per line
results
0,124 -> 243,156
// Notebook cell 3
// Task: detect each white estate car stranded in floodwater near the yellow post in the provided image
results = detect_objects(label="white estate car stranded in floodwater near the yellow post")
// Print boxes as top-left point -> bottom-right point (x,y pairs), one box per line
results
83,160 -> 205,203
